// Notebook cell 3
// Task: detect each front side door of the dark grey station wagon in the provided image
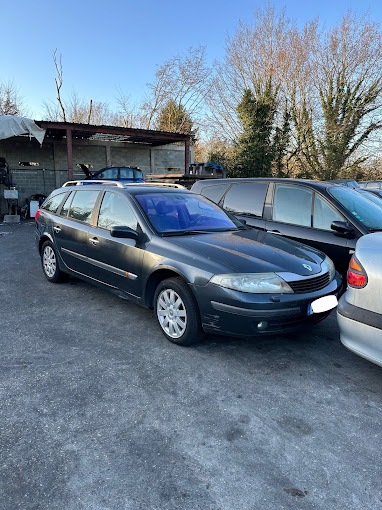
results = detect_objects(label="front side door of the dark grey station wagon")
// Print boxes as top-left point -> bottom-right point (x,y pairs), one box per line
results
87,191 -> 143,298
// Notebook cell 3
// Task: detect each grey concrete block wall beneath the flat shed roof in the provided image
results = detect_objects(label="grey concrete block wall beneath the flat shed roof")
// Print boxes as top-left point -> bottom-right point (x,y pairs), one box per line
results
0,137 -> 193,211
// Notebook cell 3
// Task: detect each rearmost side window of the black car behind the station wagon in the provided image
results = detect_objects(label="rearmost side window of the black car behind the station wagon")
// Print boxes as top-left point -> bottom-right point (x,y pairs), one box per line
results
222,182 -> 268,230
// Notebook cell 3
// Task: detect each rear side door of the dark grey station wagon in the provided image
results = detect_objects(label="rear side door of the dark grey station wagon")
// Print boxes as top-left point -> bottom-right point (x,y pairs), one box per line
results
52,189 -> 100,275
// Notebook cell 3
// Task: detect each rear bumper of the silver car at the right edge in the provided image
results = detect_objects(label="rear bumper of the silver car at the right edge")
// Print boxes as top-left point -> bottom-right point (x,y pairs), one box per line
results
337,295 -> 382,366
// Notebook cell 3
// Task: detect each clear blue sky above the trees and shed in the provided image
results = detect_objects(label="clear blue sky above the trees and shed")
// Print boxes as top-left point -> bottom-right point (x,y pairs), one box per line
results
0,0 -> 382,119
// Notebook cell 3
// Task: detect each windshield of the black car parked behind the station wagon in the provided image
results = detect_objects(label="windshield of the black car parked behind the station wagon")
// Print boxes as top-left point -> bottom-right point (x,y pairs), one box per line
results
328,186 -> 382,230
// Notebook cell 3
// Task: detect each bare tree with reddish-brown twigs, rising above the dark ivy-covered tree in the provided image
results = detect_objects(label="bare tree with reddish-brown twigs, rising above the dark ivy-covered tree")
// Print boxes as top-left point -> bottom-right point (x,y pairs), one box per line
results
208,4 -> 292,141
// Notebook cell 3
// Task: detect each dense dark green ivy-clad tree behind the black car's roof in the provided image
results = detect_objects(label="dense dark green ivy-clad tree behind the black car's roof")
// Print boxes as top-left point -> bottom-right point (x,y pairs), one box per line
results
230,79 -> 290,177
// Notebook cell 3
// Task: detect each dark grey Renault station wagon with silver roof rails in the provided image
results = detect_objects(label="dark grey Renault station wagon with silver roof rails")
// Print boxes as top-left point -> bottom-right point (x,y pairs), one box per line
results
36,181 -> 342,345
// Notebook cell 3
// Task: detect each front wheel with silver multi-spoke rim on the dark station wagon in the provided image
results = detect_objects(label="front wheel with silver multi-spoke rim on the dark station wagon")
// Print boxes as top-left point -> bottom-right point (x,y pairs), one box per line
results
154,278 -> 204,347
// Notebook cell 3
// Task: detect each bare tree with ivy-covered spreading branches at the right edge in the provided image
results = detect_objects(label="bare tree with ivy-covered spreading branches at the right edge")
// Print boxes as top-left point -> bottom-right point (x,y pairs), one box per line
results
295,12 -> 382,179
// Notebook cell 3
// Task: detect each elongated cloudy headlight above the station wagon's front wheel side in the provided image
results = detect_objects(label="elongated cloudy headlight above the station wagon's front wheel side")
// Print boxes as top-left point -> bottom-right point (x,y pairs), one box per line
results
210,273 -> 293,294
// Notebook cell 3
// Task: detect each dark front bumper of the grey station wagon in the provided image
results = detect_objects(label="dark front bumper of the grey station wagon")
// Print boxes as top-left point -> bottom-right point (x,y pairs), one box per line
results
194,277 -> 342,336
